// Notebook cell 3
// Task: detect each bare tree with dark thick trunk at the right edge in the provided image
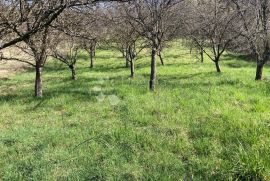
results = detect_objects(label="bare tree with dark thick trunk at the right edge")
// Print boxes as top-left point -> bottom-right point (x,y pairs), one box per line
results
232,0 -> 270,80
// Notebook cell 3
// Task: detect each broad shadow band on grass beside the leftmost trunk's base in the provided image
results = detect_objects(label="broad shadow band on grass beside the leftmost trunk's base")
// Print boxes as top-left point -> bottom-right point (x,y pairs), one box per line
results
0,76 -> 128,105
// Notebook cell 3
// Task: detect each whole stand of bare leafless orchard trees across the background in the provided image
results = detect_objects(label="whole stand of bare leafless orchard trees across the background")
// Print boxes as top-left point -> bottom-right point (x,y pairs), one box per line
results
0,0 -> 270,97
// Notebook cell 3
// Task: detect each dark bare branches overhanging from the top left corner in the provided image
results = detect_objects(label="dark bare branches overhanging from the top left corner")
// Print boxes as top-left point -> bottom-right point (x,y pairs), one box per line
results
0,0 -> 130,50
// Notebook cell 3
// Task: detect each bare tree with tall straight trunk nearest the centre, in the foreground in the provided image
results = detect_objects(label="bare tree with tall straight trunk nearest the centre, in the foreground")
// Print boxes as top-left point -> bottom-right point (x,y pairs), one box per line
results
119,0 -> 181,90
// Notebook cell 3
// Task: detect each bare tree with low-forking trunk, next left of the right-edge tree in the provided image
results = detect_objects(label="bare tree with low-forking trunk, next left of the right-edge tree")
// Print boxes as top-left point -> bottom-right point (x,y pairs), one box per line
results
186,0 -> 240,73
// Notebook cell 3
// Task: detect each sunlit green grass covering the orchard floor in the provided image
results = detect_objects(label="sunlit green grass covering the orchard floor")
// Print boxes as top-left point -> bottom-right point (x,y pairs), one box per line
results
0,43 -> 270,180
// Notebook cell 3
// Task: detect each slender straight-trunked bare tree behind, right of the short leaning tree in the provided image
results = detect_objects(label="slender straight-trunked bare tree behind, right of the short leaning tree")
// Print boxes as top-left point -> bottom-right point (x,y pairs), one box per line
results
51,4 -> 107,68
